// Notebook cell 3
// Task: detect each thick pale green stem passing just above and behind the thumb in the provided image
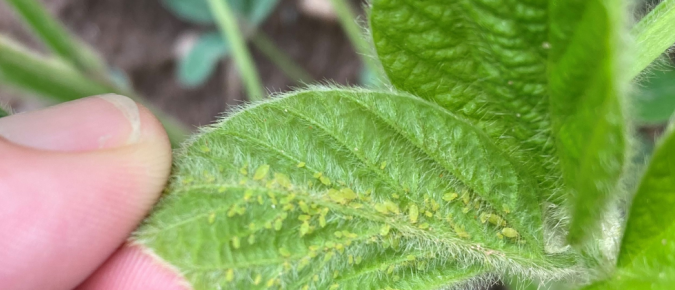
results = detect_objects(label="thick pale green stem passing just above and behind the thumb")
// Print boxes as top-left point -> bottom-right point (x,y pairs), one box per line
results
0,35 -> 187,145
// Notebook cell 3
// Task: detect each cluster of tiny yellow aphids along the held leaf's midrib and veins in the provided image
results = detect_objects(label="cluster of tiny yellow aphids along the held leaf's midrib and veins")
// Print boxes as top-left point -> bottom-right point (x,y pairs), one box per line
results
190,162 -> 524,289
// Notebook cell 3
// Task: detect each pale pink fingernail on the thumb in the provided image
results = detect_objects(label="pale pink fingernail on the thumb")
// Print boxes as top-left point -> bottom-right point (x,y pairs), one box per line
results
0,94 -> 142,152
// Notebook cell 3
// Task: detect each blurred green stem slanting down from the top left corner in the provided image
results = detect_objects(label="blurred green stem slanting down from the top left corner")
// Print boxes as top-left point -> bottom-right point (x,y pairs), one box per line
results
5,0 -> 106,77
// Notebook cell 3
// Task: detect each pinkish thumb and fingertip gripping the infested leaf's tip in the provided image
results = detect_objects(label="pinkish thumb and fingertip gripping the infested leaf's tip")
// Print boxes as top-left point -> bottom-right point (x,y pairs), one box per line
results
0,95 -> 190,290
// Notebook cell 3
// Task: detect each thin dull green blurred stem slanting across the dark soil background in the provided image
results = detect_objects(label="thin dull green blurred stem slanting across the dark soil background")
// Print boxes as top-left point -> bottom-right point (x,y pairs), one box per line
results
251,31 -> 314,83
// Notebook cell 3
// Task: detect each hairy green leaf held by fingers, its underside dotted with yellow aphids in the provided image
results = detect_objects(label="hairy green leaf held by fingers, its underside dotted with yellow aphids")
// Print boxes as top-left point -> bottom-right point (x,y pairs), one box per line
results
135,88 -> 575,289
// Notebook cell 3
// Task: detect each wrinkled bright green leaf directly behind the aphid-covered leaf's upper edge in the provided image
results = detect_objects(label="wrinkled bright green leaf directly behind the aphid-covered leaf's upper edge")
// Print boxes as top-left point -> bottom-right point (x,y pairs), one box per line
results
370,0 -> 559,199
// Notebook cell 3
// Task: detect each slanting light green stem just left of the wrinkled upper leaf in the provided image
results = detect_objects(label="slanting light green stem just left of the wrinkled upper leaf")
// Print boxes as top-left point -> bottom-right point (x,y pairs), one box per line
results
330,0 -> 380,79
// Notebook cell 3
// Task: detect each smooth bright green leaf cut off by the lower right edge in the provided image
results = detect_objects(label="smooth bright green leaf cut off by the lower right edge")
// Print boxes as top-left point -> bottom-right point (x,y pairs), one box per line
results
588,124 -> 675,290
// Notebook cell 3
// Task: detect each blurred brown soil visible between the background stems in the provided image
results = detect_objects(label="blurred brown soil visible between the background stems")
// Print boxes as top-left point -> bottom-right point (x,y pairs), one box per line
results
0,0 -> 362,128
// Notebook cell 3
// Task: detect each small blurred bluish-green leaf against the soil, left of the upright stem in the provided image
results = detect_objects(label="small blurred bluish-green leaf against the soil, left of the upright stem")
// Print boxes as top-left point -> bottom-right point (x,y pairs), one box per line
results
178,32 -> 230,87
